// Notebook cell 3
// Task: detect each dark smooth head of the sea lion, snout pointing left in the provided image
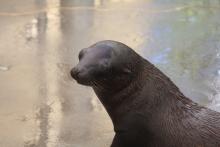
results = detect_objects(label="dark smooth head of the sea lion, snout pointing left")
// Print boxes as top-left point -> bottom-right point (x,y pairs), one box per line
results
71,40 -> 142,88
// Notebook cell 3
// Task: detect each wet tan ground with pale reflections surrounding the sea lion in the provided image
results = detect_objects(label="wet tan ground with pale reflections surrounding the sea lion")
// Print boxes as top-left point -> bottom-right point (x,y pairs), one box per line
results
0,0 -> 220,147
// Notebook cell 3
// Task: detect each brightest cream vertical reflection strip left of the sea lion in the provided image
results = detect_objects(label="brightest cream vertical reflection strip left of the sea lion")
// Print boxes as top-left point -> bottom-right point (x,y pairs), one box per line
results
44,0 -> 62,147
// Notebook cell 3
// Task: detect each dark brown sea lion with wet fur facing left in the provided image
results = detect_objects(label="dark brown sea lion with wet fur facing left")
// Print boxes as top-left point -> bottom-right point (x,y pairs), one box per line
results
71,40 -> 220,147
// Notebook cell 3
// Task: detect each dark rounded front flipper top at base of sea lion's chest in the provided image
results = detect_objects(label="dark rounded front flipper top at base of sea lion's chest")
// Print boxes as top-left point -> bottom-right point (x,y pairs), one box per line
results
111,113 -> 150,147
